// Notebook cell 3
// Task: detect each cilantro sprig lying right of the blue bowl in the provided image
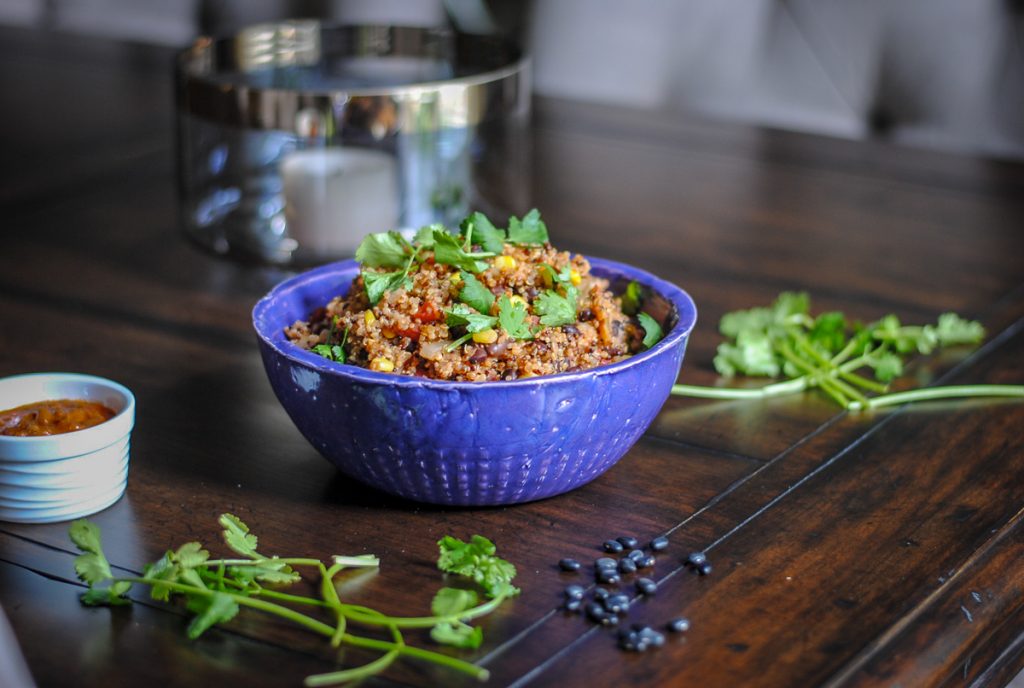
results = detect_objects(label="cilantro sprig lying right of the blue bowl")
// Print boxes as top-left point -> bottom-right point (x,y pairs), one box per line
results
672,292 -> 1024,411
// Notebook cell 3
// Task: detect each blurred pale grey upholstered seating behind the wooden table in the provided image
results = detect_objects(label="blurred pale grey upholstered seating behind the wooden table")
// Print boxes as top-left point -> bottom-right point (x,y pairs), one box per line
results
6,0 -> 1024,159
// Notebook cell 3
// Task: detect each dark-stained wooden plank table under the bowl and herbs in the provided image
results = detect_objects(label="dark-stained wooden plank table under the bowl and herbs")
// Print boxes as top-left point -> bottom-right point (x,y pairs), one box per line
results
0,24 -> 1024,687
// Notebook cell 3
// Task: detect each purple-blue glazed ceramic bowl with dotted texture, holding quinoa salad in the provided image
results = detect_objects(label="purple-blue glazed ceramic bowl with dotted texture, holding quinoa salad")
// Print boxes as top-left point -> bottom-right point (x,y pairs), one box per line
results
253,258 -> 696,505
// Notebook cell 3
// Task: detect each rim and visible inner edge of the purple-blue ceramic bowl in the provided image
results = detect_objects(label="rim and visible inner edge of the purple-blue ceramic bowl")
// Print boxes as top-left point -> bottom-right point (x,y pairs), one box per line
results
252,254 -> 697,391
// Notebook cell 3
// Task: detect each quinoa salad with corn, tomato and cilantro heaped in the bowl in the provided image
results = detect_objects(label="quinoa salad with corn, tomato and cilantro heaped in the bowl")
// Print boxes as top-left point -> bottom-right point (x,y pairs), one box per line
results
285,210 -> 662,381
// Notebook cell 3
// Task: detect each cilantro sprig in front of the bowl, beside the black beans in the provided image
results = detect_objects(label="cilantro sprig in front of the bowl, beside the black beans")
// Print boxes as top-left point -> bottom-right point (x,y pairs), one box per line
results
69,514 -> 518,686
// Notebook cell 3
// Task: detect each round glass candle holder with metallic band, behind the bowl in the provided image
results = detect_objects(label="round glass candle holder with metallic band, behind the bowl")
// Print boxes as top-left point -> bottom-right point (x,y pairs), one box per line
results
175,20 -> 529,265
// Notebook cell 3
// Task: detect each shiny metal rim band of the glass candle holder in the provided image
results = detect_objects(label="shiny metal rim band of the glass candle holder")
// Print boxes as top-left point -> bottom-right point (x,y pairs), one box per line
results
176,19 -> 530,138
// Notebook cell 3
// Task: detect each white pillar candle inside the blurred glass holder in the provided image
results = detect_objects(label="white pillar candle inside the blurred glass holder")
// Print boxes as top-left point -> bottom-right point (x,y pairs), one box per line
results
281,148 -> 400,257
